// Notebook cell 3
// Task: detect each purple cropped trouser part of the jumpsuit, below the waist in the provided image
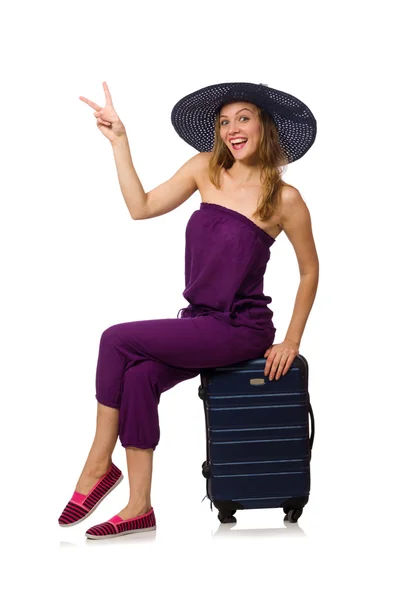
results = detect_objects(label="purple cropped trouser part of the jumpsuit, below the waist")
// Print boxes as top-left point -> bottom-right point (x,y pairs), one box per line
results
96,314 -> 275,450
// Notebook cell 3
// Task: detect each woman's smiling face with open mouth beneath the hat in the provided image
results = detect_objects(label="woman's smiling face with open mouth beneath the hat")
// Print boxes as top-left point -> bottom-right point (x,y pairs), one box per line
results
219,102 -> 261,160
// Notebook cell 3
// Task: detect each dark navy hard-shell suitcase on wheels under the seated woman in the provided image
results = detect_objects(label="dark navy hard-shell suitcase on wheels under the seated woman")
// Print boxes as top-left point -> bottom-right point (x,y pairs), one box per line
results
199,354 -> 314,523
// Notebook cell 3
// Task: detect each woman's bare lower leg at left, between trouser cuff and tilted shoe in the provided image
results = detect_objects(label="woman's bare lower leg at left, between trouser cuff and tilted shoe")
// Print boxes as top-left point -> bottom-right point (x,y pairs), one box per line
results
76,402 -> 119,494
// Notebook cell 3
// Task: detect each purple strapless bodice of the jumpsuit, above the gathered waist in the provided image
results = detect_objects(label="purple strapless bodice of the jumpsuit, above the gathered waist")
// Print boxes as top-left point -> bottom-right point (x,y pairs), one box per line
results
178,202 -> 276,331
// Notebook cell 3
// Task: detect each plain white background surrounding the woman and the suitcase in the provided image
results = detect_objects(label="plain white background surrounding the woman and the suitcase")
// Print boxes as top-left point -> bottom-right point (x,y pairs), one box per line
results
0,0 -> 396,599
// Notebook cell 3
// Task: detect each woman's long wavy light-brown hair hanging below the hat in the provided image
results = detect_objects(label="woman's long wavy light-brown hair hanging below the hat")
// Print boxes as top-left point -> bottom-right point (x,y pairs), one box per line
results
208,103 -> 293,221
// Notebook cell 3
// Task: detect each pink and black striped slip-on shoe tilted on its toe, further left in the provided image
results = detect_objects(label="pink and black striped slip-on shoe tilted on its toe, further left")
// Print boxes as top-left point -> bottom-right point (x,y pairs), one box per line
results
58,463 -> 123,527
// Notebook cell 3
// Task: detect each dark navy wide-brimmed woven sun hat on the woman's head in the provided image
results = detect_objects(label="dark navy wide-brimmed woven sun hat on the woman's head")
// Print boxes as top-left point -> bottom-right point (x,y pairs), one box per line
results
171,82 -> 317,163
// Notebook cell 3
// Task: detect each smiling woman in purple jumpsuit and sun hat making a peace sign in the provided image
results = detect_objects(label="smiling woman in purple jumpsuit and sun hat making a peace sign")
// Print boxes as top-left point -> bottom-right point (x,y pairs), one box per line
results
59,82 -> 319,539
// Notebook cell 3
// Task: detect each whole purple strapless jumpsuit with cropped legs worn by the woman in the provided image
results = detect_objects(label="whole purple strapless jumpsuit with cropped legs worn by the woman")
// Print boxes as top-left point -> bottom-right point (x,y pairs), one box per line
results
96,202 -> 276,450
